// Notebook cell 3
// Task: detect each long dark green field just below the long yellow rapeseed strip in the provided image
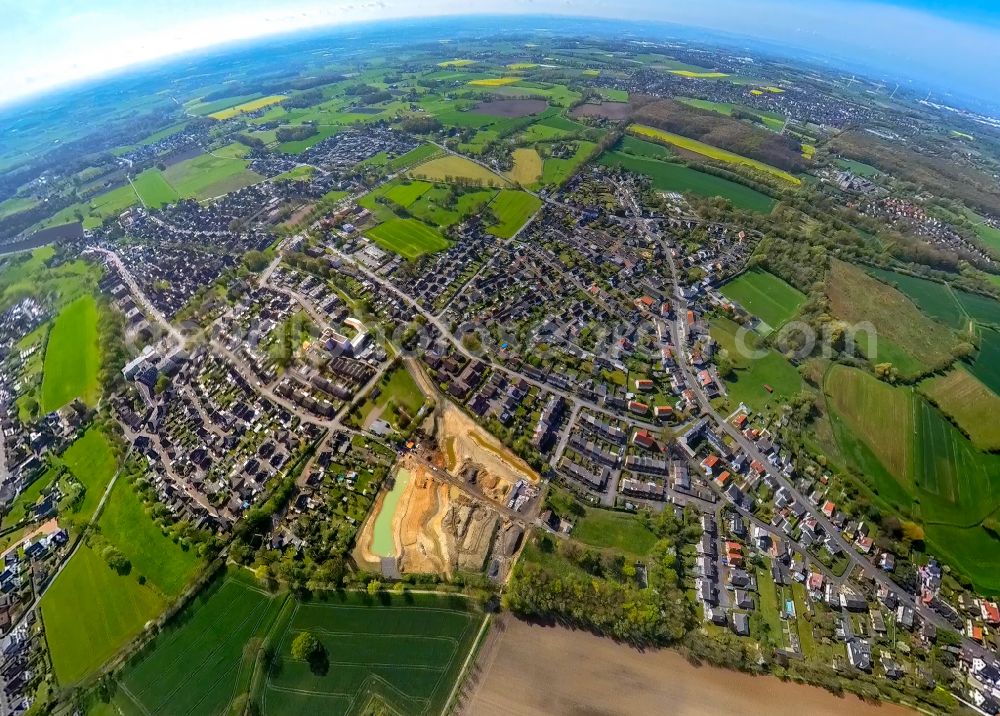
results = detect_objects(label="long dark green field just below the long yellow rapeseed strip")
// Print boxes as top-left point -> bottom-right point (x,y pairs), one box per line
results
600,147 -> 776,214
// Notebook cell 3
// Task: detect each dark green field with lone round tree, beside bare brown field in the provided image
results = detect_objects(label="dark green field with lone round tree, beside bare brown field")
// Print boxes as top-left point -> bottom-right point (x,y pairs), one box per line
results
261,592 -> 483,716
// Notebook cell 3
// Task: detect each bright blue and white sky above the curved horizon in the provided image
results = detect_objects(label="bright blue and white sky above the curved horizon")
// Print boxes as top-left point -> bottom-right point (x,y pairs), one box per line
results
0,0 -> 1000,104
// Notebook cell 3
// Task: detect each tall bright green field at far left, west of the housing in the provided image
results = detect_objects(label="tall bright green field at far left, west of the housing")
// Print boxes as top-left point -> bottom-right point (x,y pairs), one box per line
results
39,295 -> 101,413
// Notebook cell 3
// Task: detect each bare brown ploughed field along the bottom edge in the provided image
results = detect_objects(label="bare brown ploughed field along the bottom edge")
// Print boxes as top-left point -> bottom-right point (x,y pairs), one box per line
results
462,619 -> 914,716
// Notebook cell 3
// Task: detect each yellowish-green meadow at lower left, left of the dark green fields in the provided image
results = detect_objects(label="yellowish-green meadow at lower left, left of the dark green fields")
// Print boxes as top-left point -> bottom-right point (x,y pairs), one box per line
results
41,546 -> 165,686
